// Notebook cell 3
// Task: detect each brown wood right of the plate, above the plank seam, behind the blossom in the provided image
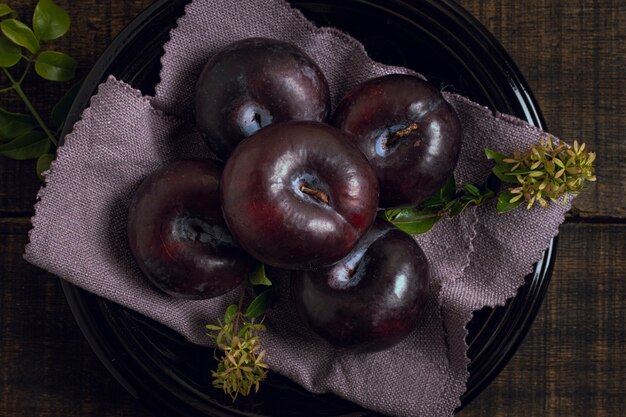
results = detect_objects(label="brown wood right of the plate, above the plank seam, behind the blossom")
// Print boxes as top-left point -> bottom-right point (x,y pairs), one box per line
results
459,0 -> 626,218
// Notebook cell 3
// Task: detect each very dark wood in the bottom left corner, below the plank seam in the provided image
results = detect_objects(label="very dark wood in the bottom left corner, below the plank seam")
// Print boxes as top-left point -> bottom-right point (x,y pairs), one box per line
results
0,219 -> 147,417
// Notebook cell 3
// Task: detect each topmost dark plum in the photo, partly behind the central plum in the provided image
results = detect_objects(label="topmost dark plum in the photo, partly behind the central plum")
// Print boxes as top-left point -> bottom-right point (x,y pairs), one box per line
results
195,38 -> 330,160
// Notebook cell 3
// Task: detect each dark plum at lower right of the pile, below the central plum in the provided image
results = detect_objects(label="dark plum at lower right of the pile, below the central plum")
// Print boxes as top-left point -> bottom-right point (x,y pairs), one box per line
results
291,219 -> 430,352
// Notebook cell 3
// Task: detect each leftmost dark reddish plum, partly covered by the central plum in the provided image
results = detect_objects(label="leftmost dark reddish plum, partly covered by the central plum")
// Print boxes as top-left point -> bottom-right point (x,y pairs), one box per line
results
128,160 -> 256,299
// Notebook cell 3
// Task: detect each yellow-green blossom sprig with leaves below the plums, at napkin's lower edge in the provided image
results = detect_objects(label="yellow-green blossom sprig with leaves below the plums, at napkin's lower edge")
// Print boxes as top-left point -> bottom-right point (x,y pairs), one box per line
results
206,264 -> 277,401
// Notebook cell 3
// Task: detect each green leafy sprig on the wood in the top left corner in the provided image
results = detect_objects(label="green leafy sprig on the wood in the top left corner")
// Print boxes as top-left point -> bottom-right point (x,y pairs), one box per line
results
0,0 -> 79,178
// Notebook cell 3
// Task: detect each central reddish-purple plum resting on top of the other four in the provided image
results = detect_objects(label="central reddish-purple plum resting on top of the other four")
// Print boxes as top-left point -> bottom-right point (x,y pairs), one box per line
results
220,121 -> 378,269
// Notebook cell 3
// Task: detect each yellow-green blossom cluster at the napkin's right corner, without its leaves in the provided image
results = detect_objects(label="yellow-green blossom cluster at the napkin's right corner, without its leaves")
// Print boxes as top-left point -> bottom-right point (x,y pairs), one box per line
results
503,136 -> 596,208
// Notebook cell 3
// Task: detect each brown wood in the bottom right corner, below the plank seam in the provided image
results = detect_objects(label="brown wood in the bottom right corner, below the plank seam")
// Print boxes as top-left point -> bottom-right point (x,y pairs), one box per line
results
460,223 -> 626,417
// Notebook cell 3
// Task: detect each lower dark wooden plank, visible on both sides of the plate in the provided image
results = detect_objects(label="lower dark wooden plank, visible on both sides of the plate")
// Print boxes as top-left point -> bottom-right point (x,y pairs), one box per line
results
0,219 -> 626,417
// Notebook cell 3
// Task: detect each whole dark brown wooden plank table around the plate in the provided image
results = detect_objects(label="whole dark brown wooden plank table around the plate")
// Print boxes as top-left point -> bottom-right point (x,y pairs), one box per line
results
0,0 -> 626,417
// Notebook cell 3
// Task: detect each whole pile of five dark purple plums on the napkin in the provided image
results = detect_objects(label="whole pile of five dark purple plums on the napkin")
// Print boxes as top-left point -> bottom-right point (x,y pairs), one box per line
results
128,38 -> 461,352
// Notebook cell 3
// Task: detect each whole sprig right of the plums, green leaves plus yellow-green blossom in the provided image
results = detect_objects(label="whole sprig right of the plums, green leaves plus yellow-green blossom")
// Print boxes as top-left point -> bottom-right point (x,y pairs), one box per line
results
379,135 -> 596,235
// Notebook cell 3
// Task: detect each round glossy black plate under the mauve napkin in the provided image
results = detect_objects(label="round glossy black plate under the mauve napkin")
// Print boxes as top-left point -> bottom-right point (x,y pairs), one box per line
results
62,0 -> 554,417
